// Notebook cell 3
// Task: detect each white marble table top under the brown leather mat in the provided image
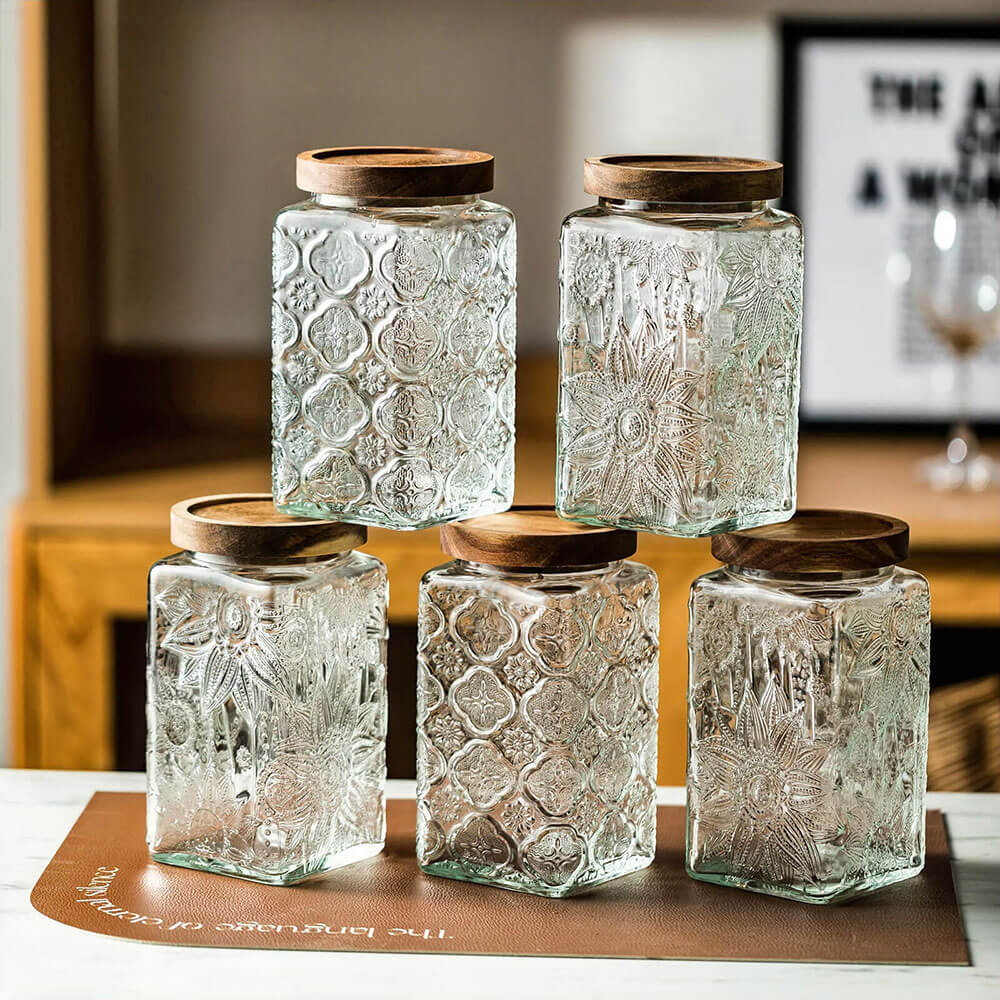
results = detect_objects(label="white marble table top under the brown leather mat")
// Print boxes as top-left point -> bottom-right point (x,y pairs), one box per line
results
0,770 -> 1000,1000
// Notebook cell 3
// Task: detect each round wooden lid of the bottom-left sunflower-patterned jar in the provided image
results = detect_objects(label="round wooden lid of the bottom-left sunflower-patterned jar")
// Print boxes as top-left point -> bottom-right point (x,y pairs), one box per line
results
170,493 -> 368,562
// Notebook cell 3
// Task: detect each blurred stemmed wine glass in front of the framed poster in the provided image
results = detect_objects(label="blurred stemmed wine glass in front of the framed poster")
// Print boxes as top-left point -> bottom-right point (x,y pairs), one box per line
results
910,200 -> 1000,490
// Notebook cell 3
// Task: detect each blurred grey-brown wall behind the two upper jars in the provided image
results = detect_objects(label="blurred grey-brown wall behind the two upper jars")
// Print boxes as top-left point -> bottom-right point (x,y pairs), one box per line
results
90,0 -> 996,352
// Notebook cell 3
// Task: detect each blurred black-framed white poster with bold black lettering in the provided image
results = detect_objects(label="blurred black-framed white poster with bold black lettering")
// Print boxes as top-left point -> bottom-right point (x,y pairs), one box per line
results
781,20 -> 1000,426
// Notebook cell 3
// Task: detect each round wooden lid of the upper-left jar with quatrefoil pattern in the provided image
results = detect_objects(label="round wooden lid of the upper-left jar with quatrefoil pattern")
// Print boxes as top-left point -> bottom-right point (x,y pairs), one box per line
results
295,146 -> 493,198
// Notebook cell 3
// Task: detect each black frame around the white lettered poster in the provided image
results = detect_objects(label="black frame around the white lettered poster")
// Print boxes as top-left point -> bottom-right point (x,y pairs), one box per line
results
778,17 -> 1000,437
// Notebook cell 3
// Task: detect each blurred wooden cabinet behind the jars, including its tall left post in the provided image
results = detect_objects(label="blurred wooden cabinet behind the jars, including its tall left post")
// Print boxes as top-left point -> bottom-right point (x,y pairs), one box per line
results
11,0 -> 1000,784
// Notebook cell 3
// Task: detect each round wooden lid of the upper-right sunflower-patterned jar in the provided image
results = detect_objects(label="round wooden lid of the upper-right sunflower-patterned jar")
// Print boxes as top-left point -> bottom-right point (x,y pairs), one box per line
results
583,155 -> 782,204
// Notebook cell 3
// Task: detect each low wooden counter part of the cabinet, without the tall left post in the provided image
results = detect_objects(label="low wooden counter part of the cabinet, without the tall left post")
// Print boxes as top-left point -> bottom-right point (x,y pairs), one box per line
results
13,434 -> 1000,784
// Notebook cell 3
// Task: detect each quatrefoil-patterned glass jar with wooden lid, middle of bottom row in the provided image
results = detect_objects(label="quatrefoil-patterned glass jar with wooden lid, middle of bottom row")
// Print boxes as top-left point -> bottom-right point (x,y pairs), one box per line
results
417,508 -> 659,896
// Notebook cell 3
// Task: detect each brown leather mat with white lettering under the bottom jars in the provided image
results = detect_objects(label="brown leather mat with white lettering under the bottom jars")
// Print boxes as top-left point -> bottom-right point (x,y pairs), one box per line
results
31,792 -> 969,965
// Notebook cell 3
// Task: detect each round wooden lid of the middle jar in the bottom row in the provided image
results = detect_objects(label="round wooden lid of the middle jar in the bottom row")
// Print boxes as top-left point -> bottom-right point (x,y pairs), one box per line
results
441,507 -> 636,569
